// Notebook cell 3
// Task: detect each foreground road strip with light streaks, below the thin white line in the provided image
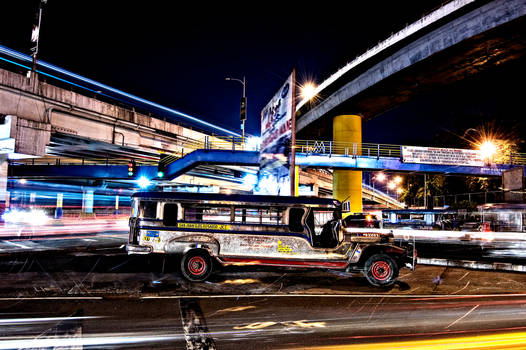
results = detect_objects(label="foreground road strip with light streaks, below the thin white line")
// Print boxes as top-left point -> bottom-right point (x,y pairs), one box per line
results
0,294 -> 526,349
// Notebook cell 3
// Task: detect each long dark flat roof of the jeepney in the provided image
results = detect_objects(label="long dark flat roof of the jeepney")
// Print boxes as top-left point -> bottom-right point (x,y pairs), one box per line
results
132,191 -> 340,207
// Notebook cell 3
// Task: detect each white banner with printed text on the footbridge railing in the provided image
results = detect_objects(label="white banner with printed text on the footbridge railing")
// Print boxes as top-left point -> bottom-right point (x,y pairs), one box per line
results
402,146 -> 484,166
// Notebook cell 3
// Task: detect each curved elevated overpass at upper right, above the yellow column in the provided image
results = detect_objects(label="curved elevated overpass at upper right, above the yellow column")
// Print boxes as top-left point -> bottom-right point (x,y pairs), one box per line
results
297,0 -> 526,137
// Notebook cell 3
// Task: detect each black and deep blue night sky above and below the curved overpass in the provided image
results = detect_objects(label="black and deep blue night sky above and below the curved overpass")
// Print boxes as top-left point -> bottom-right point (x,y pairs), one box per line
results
0,0 -> 526,148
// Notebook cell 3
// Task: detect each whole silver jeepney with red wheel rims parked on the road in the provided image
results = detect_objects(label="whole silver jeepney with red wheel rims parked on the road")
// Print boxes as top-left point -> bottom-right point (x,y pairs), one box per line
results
127,192 -> 415,286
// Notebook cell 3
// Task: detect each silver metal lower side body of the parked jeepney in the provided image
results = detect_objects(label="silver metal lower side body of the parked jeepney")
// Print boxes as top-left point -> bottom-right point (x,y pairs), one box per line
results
134,202 -> 351,260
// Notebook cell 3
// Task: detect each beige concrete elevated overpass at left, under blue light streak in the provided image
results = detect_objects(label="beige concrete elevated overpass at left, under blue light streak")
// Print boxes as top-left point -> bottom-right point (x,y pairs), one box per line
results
0,69 -> 221,160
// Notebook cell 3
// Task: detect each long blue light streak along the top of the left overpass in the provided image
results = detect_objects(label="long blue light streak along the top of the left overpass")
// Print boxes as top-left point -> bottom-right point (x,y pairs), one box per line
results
0,45 -> 241,136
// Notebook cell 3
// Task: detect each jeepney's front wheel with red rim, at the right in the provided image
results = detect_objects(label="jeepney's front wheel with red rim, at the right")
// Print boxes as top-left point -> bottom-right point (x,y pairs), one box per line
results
363,254 -> 398,287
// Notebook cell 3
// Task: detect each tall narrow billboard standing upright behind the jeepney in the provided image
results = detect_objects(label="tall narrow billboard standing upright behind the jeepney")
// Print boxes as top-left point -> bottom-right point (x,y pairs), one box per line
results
254,72 -> 295,196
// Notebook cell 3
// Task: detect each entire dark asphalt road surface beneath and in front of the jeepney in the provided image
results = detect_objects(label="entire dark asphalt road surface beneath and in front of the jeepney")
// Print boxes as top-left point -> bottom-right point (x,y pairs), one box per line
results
0,233 -> 526,349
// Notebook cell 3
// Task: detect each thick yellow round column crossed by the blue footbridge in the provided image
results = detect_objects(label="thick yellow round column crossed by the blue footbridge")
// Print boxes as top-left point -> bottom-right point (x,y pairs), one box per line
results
332,115 -> 363,213
